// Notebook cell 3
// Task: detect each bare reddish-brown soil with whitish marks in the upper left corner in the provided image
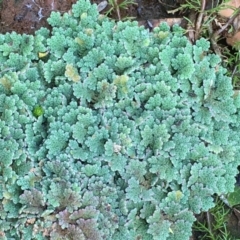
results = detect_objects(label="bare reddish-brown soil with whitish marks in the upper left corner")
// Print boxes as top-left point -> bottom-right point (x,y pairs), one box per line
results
0,0 -> 76,33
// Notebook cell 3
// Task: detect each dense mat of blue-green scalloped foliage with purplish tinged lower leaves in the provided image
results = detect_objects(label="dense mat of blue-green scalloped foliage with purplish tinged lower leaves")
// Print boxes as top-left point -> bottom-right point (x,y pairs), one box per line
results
0,0 -> 240,240
